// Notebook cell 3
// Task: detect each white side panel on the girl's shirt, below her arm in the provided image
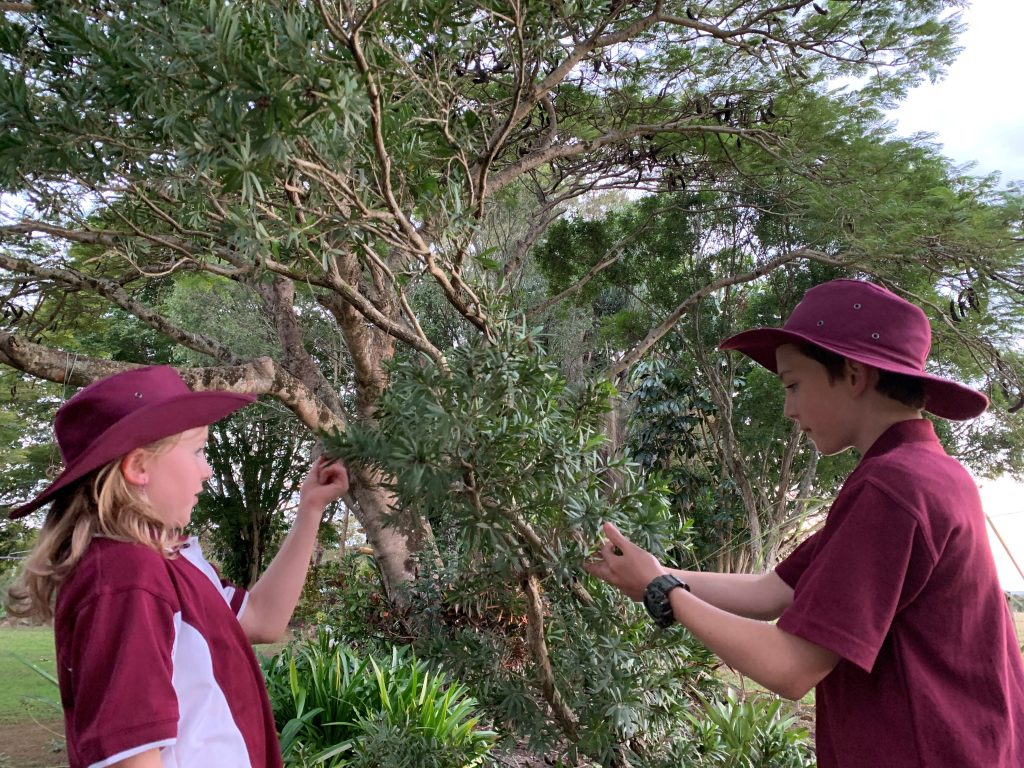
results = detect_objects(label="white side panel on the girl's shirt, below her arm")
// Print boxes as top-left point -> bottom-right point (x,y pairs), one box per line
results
160,614 -> 250,768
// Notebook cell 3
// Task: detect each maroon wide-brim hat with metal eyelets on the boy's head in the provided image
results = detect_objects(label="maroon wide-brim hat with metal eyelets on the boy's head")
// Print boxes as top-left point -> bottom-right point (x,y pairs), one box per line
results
719,280 -> 988,421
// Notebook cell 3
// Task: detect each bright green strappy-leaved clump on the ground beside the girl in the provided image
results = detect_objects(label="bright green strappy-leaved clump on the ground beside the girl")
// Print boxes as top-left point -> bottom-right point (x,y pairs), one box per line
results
264,631 -> 495,768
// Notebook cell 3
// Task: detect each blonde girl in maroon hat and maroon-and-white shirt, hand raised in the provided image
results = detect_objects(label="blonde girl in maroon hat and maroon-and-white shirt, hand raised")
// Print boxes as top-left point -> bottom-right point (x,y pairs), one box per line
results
9,366 -> 348,768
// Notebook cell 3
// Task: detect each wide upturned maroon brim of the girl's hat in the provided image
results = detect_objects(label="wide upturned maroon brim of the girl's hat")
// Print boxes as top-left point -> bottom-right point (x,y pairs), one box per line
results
8,391 -> 256,520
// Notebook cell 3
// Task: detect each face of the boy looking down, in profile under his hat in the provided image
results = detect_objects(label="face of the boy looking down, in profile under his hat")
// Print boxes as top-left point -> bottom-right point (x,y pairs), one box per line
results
775,344 -> 856,456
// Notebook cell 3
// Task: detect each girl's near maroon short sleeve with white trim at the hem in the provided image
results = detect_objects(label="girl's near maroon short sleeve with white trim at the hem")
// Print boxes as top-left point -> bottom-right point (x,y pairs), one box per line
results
60,589 -> 178,766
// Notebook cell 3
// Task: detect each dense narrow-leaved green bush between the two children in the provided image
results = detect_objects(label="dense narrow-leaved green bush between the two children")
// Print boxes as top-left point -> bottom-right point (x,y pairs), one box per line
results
331,328 -> 733,766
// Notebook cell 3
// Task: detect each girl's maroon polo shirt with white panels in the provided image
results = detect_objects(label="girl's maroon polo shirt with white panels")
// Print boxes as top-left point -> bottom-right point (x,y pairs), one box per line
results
53,538 -> 282,768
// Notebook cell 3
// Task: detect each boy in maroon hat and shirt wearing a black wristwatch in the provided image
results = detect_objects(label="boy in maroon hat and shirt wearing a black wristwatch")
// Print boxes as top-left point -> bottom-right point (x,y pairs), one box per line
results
587,280 -> 1024,768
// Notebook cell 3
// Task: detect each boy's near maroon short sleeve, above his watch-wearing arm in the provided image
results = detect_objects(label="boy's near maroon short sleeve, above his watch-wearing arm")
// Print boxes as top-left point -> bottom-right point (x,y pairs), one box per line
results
778,482 -> 934,672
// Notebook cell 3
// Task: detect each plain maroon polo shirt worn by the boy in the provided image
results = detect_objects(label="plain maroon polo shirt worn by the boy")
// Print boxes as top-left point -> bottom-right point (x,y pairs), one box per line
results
776,419 -> 1024,768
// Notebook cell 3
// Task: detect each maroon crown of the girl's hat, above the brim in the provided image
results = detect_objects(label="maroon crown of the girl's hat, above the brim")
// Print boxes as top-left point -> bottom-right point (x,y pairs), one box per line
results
53,366 -> 190,466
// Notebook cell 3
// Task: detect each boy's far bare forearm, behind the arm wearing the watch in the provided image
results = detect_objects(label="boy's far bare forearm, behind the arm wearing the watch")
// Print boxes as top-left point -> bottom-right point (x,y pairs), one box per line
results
666,568 -> 793,622
